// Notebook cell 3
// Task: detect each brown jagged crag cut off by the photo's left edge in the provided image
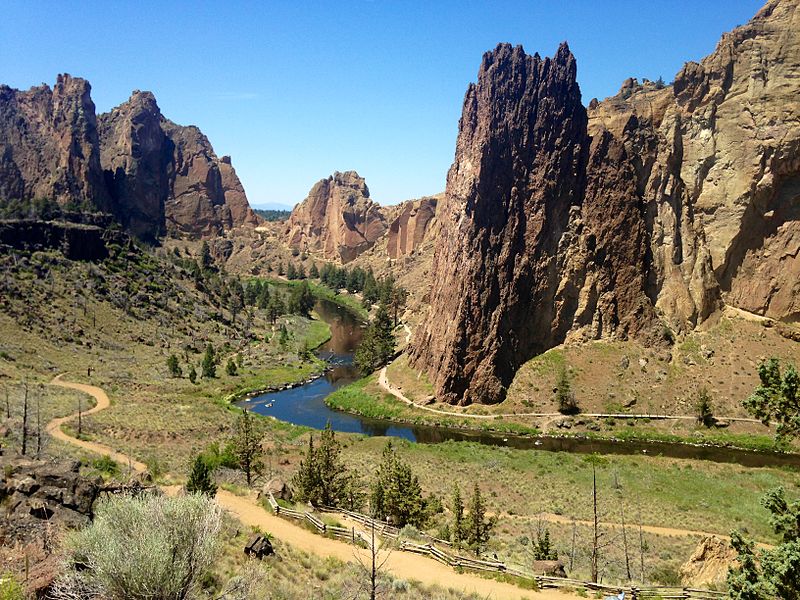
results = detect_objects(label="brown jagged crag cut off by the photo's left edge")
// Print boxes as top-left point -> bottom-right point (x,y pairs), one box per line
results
0,75 -> 110,210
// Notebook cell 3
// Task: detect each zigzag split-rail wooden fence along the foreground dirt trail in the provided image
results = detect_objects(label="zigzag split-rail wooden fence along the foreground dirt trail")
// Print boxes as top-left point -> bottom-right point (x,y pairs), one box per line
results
267,493 -> 727,600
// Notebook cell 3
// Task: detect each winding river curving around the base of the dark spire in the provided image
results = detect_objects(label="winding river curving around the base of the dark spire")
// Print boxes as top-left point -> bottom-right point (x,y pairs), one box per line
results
238,300 -> 800,467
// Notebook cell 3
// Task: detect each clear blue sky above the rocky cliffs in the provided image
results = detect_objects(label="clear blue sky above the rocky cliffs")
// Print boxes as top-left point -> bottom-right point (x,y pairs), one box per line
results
0,0 -> 763,205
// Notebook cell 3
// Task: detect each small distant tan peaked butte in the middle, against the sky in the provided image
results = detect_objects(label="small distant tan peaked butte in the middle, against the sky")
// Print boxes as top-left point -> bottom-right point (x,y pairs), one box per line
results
285,171 -> 387,263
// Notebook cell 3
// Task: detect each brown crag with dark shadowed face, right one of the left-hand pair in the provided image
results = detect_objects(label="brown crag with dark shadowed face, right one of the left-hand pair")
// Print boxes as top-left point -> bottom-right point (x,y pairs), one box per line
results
99,91 -> 260,238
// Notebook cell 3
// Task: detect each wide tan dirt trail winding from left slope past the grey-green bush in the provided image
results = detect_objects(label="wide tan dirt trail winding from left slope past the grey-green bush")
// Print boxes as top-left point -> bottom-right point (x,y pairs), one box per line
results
46,375 -> 577,600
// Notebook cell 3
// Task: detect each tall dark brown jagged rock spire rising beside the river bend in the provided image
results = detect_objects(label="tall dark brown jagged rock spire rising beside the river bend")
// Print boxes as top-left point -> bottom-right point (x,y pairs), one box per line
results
412,44 -> 589,403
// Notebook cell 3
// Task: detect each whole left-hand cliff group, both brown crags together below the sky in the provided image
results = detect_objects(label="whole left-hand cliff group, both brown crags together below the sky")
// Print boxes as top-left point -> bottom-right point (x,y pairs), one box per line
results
0,75 -> 260,239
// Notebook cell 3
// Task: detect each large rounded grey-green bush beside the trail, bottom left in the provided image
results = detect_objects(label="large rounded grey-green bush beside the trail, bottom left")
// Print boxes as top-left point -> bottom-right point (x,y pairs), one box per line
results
53,494 -> 222,600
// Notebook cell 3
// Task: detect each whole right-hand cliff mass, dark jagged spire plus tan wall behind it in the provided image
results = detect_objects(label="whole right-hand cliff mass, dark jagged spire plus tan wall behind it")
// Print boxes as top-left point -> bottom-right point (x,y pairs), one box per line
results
411,0 -> 800,404
